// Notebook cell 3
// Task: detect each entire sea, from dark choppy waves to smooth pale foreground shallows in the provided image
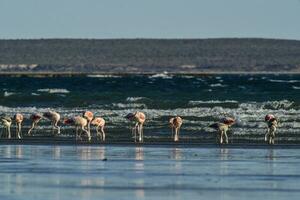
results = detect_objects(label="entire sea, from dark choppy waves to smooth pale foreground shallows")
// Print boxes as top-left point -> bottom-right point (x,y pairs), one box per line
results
0,73 -> 300,200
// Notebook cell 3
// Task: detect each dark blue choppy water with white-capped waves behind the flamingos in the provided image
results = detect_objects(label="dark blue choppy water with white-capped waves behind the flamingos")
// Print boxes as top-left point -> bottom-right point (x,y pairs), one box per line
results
0,74 -> 300,141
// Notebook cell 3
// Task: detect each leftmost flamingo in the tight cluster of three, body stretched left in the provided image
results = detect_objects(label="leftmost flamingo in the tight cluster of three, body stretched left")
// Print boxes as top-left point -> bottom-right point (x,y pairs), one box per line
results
64,116 -> 91,141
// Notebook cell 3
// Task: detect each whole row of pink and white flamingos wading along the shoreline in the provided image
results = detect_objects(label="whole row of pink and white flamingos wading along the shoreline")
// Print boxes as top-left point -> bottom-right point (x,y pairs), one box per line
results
0,111 -> 278,144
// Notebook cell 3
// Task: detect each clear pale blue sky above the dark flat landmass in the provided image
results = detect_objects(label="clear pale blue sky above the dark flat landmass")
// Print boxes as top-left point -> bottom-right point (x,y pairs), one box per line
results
0,0 -> 300,40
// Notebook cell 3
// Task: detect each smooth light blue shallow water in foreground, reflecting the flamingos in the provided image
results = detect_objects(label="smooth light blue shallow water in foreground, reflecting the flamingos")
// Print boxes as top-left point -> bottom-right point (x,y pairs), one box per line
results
0,145 -> 300,200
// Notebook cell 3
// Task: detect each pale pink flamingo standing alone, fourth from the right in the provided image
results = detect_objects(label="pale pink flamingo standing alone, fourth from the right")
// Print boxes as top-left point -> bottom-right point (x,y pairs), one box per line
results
125,111 -> 146,142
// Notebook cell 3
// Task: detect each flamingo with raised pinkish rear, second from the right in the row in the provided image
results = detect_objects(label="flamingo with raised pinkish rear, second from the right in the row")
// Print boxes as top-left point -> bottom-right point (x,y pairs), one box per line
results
209,117 -> 235,144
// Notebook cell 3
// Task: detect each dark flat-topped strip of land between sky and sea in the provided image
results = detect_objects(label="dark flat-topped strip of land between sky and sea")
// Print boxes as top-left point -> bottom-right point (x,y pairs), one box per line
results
0,39 -> 300,74
